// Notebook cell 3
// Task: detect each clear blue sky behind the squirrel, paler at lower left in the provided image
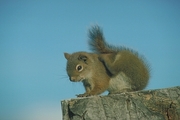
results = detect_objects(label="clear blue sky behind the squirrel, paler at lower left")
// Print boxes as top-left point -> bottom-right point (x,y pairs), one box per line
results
0,0 -> 180,120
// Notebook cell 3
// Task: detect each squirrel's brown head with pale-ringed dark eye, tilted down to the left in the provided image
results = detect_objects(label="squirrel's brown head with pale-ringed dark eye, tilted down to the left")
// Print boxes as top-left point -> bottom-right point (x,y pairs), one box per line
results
64,52 -> 91,82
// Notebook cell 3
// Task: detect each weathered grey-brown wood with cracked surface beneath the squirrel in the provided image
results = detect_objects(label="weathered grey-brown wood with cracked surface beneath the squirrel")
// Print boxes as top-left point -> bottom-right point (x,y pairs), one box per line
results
61,86 -> 180,120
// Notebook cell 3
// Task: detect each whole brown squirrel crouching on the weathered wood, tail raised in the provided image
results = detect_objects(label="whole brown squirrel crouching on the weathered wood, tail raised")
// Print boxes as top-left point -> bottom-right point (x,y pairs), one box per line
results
64,25 -> 150,97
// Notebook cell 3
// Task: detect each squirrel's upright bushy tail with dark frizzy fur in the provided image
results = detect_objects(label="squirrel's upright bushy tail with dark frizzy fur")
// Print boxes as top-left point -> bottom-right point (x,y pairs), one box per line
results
89,25 -> 116,53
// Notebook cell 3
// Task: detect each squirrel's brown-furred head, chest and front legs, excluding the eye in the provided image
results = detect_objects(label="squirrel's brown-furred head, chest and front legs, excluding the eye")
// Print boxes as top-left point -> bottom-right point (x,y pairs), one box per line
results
64,52 -> 110,97
